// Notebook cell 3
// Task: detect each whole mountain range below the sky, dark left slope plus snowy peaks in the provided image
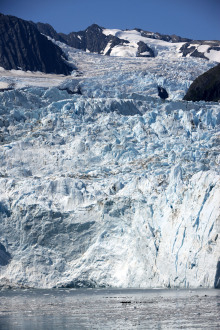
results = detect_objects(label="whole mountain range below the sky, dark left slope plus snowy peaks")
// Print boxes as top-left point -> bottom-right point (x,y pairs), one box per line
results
0,14 -> 220,75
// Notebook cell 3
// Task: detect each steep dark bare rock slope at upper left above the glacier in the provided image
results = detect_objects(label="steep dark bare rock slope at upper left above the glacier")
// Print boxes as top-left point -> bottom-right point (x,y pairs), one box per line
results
0,14 -> 72,75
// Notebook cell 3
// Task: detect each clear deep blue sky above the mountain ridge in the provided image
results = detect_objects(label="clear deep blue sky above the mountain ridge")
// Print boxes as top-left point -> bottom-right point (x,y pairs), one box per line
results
0,0 -> 220,40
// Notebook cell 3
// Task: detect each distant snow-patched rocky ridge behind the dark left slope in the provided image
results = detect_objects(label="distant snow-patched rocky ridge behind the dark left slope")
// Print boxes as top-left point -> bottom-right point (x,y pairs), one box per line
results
36,23 -> 220,62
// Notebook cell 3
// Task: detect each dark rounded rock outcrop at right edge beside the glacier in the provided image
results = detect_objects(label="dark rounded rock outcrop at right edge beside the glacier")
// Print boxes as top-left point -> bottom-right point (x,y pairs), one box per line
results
183,64 -> 220,102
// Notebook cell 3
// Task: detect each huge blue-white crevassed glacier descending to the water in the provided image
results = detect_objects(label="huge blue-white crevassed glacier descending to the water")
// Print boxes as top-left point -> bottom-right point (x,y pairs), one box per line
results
0,41 -> 220,288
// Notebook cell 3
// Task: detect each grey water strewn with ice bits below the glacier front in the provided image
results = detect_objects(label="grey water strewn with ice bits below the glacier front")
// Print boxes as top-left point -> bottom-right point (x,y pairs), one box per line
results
0,289 -> 220,330
